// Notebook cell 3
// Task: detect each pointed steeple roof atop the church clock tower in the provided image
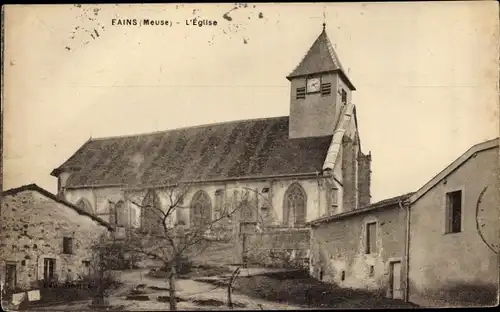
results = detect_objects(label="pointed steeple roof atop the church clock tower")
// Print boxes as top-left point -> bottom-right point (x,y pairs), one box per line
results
286,24 -> 356,90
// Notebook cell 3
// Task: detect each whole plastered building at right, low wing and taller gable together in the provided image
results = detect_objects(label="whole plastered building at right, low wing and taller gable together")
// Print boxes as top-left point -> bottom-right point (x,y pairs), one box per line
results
308,139 -> 500,307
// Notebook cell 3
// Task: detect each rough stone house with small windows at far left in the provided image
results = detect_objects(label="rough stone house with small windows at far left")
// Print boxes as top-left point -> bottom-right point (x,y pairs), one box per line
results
0,184 -> 112,289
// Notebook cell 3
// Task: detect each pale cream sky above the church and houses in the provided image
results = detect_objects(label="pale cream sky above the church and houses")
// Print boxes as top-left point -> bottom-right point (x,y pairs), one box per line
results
3,1 -> 499,201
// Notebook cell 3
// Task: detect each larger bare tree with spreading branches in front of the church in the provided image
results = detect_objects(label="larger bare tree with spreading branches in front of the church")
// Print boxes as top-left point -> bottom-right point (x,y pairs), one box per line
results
118,184 -> 270,310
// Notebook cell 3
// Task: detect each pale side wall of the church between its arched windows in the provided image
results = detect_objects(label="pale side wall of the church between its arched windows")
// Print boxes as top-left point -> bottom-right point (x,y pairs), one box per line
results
64,177 -> 327,228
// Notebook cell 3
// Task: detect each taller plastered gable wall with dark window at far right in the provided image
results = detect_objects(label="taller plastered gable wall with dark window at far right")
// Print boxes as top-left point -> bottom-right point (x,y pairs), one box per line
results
408,139 -> 500,306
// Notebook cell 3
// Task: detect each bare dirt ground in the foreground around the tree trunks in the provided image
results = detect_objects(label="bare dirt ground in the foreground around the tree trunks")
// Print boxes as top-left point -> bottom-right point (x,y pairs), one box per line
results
20,269 -> 417,311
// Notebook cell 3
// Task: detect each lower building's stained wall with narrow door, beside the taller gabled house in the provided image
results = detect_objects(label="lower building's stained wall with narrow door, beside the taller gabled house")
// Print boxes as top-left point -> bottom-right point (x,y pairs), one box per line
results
310,194 -> 410,299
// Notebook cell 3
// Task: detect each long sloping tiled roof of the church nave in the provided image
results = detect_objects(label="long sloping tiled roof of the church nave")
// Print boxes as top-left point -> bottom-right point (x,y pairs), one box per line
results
51,116 -> 332,188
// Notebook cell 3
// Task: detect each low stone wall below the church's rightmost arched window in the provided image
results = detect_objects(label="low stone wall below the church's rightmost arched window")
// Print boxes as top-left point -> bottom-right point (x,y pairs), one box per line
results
240,228 -> 310,269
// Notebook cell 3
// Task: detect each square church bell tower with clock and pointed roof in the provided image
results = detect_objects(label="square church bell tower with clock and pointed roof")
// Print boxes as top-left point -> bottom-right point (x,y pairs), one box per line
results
286,23 -> 356,139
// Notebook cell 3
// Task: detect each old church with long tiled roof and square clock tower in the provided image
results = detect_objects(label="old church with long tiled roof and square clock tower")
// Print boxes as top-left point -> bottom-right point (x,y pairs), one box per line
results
51,24 -> 371,264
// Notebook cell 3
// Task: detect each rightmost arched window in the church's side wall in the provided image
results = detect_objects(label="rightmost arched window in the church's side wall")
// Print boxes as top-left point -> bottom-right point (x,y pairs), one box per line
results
283,183 -> 307,226
